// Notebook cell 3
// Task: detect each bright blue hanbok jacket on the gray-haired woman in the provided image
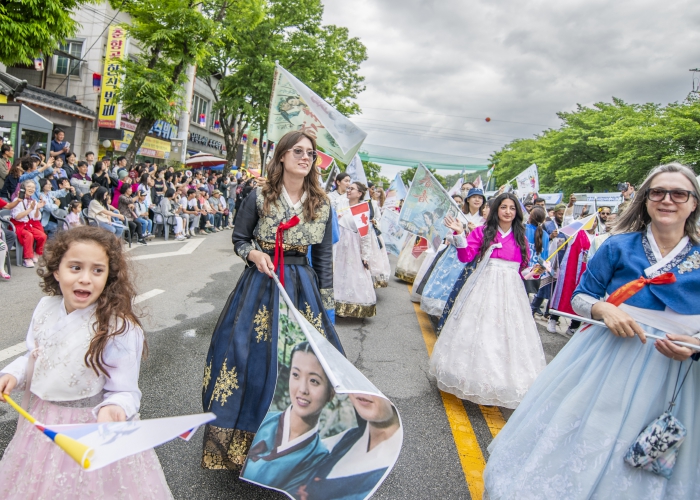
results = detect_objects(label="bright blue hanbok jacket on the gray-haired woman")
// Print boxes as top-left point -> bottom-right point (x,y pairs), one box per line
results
574,232 -> 700,314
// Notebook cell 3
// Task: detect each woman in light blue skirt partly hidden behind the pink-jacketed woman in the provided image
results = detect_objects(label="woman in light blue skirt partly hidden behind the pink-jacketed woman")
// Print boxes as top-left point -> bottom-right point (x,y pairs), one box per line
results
420,188 -> 486,316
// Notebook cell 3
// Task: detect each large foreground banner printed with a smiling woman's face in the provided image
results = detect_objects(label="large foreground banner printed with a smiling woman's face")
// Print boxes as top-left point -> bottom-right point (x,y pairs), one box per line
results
241,297 -> 403,500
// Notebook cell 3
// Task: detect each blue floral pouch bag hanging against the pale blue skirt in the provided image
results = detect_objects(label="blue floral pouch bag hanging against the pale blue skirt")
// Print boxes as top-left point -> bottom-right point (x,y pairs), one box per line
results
625,356 -> 696,479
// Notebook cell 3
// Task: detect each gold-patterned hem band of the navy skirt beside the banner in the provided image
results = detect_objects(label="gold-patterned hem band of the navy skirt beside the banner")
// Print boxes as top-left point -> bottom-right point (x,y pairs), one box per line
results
202,425 -> 255,472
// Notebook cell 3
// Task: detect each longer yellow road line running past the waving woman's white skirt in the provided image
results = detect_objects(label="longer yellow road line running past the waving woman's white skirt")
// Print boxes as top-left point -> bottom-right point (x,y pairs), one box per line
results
408,285 -> 486,500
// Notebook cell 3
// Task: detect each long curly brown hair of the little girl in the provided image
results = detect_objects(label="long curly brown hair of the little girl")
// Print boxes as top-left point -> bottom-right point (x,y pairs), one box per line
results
37,226 -> 147,377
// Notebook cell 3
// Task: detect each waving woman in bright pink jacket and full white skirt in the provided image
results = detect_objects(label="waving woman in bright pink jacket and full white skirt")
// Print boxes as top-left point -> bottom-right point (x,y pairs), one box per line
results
430,193 -> 546,408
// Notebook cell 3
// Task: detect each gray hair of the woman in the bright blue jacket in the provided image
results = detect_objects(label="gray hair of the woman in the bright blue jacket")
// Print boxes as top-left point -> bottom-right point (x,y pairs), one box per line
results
611,162 -> 700,244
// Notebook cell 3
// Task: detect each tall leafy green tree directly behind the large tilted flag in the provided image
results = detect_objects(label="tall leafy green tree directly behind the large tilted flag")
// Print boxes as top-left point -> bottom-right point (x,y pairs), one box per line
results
200,0 -> 367,176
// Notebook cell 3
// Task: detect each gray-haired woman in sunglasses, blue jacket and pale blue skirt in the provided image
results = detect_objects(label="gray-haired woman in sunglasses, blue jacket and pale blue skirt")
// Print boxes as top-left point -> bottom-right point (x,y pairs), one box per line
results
484,163 -> 700,500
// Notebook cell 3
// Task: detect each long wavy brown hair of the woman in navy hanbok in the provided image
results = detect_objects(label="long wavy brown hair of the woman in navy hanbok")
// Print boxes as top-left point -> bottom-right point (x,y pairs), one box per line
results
262,131 -> 328,221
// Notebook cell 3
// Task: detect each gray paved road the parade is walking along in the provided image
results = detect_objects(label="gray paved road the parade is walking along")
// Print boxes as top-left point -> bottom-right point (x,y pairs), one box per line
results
0,231 -> 566,500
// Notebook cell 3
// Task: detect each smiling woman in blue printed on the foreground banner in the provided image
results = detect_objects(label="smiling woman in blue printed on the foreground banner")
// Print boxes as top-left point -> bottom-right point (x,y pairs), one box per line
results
241,342 -> 335,494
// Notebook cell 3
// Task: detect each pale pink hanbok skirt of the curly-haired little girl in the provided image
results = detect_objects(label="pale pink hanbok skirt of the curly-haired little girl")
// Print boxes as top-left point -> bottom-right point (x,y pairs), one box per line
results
0,394 -> 173,500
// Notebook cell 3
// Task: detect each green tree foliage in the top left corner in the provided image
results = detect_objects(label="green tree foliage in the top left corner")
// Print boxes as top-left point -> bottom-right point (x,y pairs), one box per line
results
0,0 -> 94,66
